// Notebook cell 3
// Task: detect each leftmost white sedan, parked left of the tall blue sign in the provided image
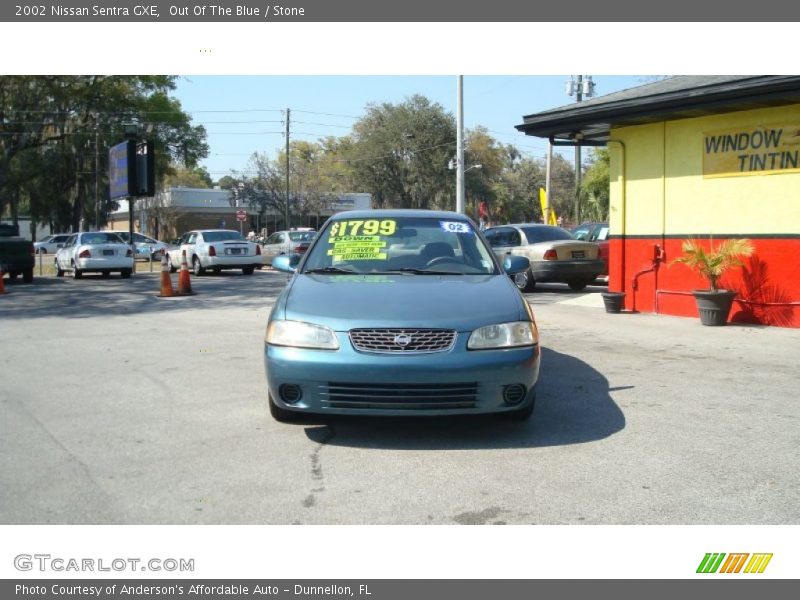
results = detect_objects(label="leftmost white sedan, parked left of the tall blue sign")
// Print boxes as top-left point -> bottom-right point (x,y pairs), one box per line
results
55,231 -> 133,279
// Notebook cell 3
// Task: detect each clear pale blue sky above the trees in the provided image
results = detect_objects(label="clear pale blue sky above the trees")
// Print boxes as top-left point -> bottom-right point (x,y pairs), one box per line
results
173,75 -> 646,181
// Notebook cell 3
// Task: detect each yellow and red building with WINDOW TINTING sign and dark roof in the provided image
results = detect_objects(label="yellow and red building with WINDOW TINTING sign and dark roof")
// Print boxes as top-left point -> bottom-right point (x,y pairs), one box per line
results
517,75 -> 800,327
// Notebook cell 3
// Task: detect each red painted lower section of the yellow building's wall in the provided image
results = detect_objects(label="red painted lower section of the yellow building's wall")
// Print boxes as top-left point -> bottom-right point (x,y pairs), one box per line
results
609,237 -> 800,327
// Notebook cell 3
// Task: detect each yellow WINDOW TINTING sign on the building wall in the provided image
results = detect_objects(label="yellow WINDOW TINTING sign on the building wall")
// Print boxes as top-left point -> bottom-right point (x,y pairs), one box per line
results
703,123 -> 800,177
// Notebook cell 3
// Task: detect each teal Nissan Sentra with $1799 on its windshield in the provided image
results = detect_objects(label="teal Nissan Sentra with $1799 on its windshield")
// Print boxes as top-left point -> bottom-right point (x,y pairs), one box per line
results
264,210 -> 540,421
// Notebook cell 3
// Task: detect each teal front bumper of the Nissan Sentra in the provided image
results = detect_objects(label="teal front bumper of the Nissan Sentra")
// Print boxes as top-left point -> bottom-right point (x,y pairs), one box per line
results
264,332 -> 540,416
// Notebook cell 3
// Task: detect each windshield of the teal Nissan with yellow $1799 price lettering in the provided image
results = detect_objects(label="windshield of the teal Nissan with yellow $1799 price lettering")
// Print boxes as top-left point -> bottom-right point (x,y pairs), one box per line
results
303,216 -> 498,275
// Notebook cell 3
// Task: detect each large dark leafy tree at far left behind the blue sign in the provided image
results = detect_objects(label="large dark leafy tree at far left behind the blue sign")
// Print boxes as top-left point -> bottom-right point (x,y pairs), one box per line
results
0,75 -> 208,230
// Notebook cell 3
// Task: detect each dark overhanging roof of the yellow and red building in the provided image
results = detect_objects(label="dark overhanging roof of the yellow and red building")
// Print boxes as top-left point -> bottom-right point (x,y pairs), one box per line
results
516,75 -> 800,145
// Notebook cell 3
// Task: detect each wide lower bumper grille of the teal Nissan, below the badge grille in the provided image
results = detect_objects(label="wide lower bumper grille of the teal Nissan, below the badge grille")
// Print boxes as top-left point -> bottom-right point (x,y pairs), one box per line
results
320,382 -> 478,410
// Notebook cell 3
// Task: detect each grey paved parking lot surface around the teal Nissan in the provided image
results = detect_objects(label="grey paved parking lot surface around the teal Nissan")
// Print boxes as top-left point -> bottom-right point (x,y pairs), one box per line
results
0,271 -> 800,524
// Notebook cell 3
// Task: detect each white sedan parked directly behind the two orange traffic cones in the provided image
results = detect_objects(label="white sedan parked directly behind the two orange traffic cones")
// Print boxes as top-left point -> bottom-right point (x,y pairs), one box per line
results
167,229 -> 262,275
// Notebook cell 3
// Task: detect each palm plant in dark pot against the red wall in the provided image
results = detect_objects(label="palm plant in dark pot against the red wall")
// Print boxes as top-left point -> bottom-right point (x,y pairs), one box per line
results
673,238 -> 753,325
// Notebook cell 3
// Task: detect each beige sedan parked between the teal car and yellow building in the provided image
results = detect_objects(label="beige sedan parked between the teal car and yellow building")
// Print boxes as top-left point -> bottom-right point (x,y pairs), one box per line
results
484,223 -> 604,292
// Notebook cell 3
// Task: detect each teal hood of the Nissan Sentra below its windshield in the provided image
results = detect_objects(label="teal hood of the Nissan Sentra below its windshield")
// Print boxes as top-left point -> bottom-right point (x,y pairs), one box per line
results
274,274 -> 528,331
